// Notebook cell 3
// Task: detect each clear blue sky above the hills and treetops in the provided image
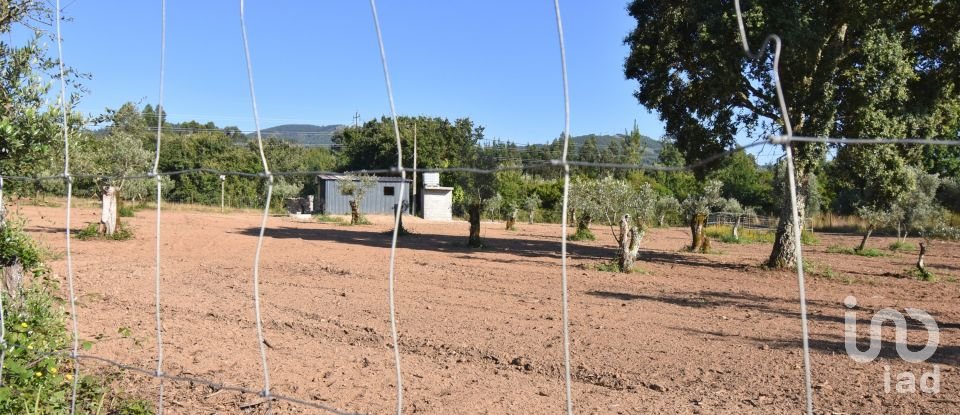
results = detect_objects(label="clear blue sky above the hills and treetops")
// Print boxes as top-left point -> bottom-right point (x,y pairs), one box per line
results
37,0 -> 663,143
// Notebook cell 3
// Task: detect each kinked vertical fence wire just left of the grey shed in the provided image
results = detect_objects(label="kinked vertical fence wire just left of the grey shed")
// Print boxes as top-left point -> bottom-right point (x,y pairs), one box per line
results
240,0 -> 273,406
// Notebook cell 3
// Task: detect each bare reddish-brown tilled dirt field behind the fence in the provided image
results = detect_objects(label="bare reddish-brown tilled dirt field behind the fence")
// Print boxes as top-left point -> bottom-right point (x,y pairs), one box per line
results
14,201 -> 960,414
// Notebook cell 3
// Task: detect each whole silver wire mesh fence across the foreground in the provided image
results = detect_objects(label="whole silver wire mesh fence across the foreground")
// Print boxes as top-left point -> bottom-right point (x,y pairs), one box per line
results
0,0 -> 960,415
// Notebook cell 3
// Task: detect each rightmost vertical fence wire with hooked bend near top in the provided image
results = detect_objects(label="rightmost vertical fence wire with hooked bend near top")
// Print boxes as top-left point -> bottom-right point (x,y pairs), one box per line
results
733,0 -> 813,415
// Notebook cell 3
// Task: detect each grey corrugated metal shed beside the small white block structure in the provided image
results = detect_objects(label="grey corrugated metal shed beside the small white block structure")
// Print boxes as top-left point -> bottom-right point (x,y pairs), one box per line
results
314,174 -> 410,215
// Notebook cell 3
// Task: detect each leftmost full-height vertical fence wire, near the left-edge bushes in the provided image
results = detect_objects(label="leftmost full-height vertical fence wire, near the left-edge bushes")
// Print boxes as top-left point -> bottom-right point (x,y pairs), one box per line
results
55,0 -> 80,415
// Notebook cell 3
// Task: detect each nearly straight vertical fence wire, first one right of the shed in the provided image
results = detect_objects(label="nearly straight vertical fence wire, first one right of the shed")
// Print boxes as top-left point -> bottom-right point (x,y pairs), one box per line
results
553,0 -> 573,415
